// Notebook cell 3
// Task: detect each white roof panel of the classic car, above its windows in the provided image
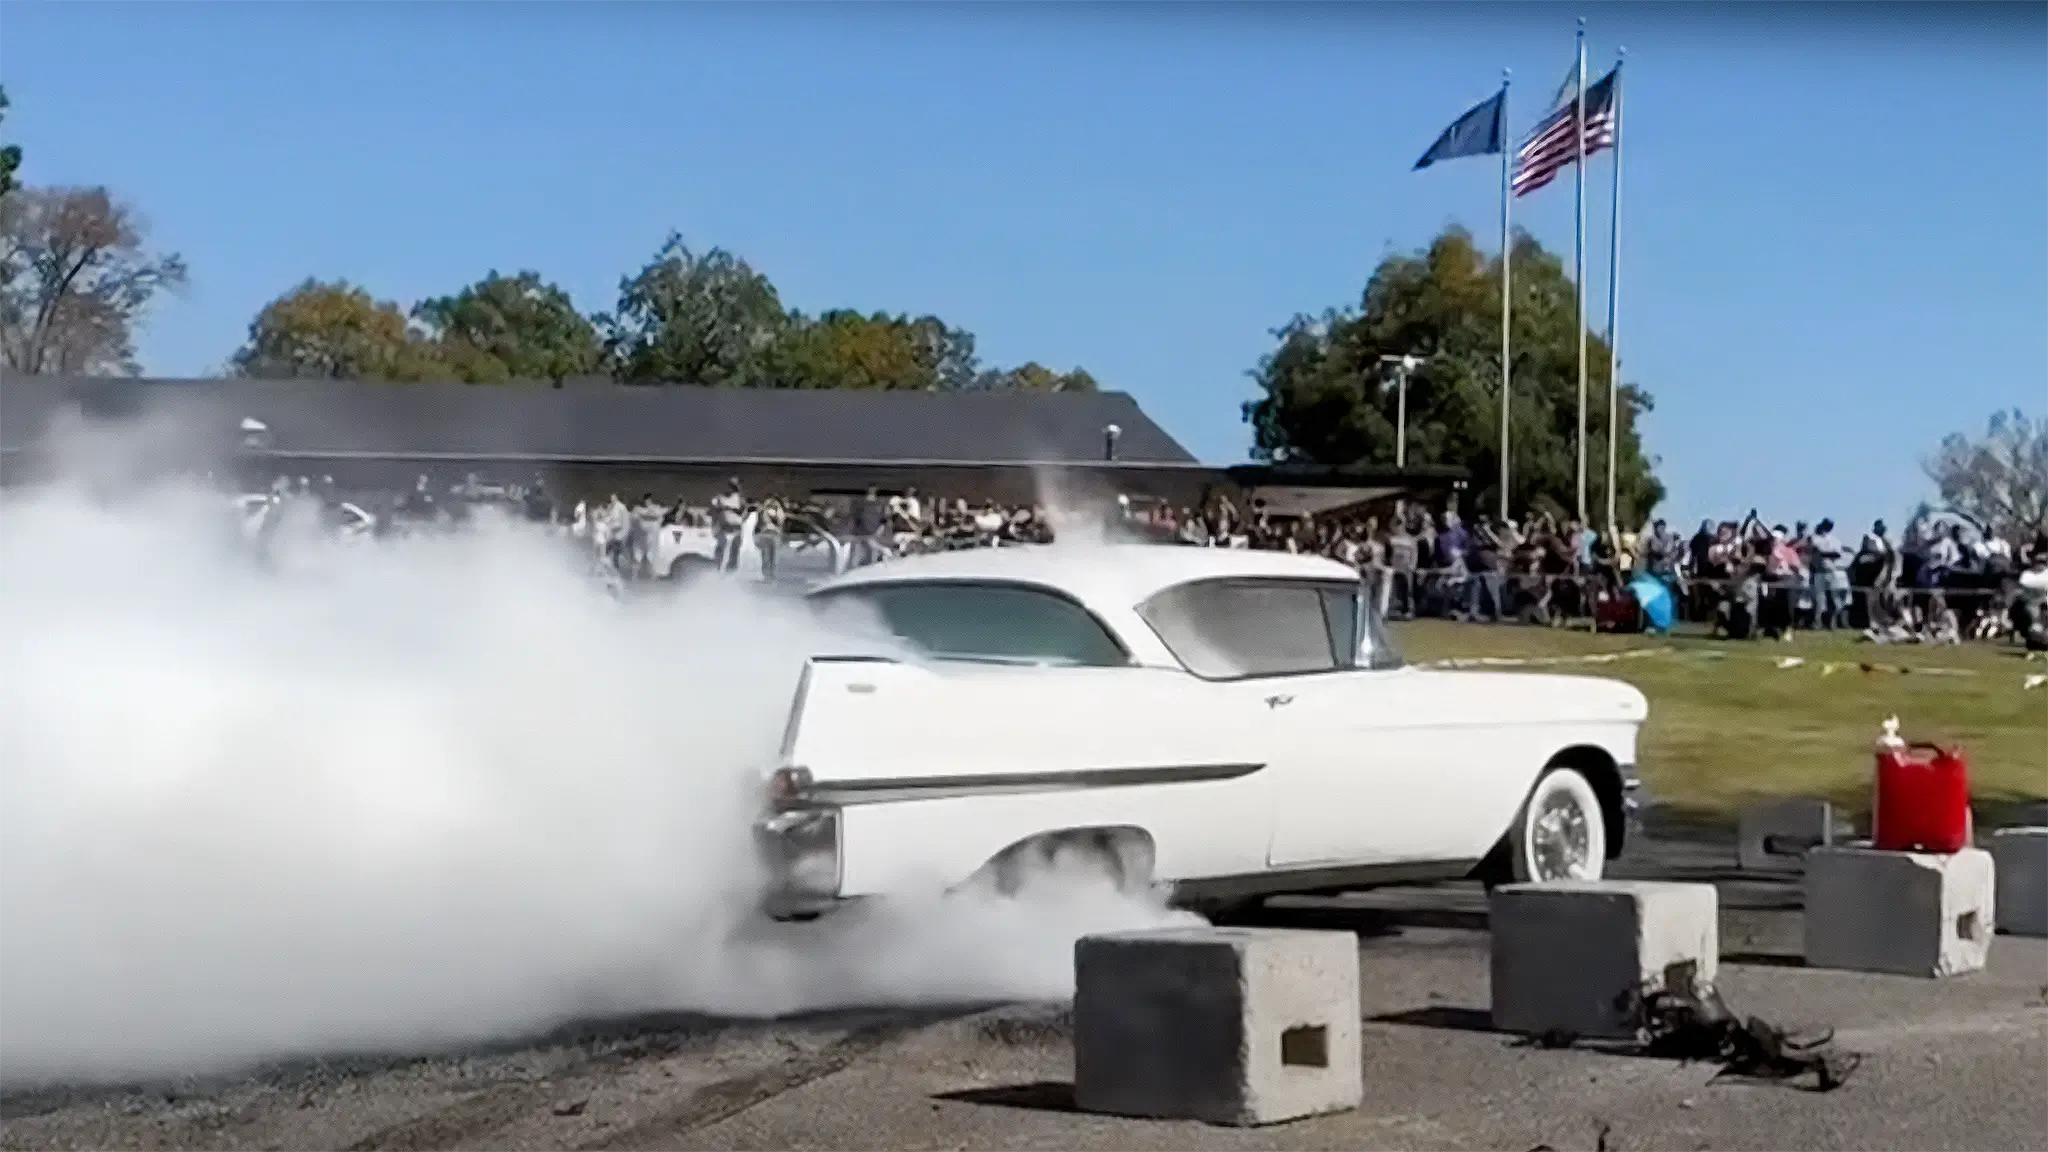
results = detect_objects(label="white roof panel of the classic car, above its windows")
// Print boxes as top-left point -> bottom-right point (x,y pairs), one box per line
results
811,543 -> 1358,609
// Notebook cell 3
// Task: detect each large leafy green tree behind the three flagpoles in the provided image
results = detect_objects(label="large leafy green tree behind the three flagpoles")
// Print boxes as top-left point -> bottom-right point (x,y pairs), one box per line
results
1243,228 -> 1665,525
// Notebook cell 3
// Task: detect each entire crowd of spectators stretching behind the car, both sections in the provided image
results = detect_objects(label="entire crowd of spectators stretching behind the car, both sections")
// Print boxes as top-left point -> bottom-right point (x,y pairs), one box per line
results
243,476 -> 2048,648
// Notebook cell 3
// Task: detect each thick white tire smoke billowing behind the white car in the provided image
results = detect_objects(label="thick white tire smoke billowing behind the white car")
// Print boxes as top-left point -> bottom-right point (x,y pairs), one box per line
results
0,467 -> 1167,1084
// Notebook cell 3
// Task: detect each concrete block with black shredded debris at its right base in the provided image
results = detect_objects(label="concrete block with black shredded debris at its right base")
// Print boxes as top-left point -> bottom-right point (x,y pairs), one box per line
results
1491,879 -> 1720,1039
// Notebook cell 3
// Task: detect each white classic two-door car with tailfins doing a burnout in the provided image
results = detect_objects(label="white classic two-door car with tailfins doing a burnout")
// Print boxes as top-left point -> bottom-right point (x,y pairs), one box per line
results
756,545 -> 1647,916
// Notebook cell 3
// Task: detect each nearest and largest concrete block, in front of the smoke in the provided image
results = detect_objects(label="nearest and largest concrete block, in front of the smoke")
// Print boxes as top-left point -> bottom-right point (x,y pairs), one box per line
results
1073,927 -> 1364,1125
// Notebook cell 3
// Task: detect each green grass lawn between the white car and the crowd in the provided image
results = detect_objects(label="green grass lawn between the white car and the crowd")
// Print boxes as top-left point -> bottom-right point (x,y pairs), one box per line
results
1395,621 -> 2048,822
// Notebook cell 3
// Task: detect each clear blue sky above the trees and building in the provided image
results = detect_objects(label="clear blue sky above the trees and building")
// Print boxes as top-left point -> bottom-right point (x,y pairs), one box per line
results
0,0 -> 2048,521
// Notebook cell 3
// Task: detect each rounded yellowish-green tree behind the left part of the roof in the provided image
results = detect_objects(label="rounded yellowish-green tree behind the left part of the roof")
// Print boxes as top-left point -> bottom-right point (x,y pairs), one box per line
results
233,279 -> 457,381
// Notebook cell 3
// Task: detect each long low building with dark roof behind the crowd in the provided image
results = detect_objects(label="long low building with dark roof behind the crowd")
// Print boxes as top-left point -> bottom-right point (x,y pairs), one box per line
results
0,377 -> 1454,502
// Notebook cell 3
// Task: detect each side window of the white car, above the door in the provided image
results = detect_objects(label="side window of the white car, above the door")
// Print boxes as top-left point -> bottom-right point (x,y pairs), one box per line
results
1139,580 -> 1358,681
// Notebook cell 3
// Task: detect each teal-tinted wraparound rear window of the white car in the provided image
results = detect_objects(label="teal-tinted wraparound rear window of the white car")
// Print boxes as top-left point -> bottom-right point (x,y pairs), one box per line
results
815,582 -> 1130,668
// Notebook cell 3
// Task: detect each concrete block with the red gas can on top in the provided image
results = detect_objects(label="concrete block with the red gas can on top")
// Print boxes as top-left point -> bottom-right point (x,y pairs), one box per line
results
1806,845 -> 1997,976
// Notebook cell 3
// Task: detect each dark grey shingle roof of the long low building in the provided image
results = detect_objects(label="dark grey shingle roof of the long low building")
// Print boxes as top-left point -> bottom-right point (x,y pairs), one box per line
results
0,375 -> 1194,463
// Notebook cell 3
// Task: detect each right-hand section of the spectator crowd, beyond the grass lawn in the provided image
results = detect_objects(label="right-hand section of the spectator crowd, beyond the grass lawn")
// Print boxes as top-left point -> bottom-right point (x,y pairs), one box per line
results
1139,500 -> 2048,648
